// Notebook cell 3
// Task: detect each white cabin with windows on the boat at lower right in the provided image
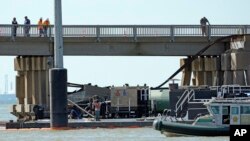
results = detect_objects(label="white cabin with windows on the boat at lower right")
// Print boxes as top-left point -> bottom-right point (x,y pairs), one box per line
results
206,97 -> 250,125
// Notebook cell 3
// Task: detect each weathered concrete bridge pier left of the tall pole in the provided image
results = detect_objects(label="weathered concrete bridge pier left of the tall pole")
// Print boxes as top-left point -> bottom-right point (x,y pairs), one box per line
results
11,56 -> 53,120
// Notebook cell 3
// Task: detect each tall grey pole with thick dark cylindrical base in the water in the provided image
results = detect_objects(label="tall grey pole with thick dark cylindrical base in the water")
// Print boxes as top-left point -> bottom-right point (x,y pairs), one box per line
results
49,0 -> 68,128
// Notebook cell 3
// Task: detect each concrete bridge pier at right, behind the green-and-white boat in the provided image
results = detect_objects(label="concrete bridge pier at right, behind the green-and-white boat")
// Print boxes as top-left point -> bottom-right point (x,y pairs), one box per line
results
180,37 -> 250,86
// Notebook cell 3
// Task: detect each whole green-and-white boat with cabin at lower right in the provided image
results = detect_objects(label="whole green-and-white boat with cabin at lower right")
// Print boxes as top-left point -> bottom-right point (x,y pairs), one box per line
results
153,85 -> 250,136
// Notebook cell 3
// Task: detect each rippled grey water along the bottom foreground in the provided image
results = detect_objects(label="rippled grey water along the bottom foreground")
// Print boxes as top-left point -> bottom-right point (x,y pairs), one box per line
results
0,128 -> 229,141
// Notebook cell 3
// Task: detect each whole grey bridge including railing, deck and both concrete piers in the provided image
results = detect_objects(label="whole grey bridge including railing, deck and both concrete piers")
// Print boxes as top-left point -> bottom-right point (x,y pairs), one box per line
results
0,25 -> 250,119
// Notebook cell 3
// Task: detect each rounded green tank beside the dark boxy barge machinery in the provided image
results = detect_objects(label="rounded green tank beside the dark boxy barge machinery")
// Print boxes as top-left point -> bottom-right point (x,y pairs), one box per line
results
149,89 -> 170,113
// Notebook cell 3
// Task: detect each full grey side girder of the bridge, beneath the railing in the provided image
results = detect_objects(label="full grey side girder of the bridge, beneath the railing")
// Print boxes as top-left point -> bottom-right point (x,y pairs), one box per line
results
0,37 -> 232,56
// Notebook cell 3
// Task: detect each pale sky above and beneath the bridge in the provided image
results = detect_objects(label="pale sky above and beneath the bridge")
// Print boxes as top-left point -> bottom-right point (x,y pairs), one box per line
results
0,0 -> 250,93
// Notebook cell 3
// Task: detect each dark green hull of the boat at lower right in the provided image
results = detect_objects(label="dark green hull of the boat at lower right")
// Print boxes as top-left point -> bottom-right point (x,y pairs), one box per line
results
153,119 -> 229,136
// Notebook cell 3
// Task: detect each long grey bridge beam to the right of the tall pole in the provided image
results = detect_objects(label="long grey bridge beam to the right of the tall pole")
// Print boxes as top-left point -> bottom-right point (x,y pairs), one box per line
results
64,42 -> 225,56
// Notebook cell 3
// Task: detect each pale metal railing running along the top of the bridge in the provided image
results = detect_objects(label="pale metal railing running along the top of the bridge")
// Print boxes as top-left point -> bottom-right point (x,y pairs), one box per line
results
0,24 -> 250,40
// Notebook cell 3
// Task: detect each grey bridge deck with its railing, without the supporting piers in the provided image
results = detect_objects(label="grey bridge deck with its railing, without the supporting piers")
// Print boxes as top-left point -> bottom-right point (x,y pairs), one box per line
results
0,25 -> 250,56
